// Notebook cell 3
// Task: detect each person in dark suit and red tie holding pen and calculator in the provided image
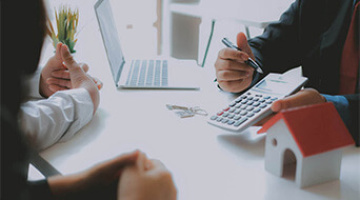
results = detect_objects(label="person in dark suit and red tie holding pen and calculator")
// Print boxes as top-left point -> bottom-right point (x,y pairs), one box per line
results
215,0 -> 360,146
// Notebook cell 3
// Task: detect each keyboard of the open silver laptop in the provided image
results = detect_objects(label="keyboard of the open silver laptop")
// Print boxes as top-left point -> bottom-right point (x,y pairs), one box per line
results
126,60 -> 168,87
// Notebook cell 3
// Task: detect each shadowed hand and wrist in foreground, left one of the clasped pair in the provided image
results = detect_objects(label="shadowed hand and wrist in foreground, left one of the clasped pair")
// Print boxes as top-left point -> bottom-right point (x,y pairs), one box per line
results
48,151 -> 140,199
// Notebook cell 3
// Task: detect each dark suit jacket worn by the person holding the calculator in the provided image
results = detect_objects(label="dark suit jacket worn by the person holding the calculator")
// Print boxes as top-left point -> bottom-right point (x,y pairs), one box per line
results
249,0 -> 360,145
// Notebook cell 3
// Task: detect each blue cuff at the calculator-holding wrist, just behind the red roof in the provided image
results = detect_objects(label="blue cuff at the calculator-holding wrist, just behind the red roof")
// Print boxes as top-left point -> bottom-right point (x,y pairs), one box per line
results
321,94 -> 351,127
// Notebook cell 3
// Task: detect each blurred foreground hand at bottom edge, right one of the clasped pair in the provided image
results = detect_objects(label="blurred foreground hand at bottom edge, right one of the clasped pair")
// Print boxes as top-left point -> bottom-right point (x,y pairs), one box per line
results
118,154 -> 177,200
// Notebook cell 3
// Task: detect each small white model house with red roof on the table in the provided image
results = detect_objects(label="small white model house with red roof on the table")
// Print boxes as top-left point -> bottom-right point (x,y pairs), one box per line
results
258,103 -> 354,188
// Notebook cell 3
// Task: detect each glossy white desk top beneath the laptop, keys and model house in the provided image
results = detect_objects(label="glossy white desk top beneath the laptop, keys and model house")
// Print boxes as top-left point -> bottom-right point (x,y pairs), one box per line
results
40,11 -> 360,200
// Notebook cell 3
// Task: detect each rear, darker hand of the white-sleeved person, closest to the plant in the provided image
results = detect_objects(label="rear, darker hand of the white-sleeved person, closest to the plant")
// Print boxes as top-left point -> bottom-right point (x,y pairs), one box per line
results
39,43 -> 102,98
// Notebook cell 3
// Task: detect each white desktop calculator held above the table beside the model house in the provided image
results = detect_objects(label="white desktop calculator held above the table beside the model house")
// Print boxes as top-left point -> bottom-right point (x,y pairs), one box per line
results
208,73 -> 307,132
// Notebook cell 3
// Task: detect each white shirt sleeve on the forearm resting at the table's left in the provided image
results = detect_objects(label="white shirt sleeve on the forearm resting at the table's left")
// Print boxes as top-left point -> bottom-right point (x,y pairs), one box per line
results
19,69 -> 94,150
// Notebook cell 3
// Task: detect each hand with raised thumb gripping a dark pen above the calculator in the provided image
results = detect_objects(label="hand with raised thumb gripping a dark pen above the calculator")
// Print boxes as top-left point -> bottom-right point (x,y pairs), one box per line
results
215,32 -> 255,93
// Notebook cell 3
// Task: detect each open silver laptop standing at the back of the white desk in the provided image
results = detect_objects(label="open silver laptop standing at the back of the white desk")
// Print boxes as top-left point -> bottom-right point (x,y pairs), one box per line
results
94,0 -> 199,90
